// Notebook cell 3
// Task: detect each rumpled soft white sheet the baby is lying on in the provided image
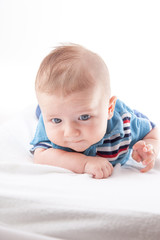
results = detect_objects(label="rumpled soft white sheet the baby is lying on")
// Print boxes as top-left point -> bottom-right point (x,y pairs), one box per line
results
0,107 -> 160,240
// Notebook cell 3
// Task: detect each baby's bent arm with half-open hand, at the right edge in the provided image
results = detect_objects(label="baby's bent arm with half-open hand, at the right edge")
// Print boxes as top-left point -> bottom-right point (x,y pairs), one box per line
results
132,127 -> 160,172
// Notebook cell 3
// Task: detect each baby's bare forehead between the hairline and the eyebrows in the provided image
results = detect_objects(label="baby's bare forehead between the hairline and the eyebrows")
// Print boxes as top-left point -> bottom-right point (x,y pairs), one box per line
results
38,87 -> 105,113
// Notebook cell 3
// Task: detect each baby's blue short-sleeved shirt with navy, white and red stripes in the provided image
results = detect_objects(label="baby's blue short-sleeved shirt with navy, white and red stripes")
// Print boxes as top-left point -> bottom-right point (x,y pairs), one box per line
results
31,100 -> 155,166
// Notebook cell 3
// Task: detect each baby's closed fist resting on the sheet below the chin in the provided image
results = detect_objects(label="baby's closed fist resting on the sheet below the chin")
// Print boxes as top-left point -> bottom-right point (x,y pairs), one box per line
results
84,156 -> 113,179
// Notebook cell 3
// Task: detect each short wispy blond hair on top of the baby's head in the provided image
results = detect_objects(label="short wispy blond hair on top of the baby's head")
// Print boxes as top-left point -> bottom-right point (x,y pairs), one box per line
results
35,44 -> 110,95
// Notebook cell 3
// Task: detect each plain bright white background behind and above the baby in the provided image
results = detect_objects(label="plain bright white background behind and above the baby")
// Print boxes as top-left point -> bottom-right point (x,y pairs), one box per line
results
0,0 -> 160,122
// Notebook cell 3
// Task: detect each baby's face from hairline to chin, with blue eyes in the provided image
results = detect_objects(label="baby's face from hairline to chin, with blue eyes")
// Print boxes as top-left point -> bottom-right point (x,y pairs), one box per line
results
38,87 -> 108,152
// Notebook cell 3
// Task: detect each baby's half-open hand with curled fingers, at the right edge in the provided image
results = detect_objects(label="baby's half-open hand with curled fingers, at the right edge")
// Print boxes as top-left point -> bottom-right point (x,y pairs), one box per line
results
132,140 -> 155,172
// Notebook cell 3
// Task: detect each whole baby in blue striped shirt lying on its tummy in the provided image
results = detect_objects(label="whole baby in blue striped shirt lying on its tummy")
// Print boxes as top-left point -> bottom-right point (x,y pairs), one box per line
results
31,44 -> 160,179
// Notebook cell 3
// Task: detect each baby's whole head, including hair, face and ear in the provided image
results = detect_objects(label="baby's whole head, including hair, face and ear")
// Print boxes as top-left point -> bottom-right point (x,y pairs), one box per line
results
36,45 -> 116,152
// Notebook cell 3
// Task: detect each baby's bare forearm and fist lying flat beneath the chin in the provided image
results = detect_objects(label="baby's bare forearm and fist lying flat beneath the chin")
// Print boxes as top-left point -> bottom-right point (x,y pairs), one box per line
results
34,148 -> 113,178
